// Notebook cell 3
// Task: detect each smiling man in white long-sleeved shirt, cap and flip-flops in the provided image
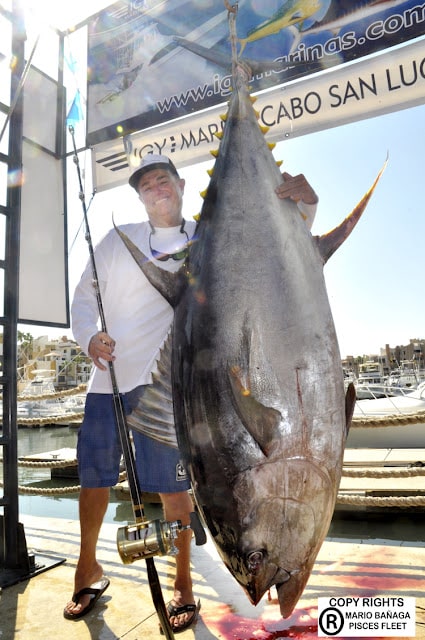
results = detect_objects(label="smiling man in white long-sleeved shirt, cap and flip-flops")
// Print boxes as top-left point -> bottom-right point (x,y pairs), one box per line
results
64,155 -> 317,632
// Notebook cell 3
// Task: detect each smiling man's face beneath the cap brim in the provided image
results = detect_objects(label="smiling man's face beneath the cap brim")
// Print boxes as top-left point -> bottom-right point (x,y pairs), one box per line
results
137,169 -> 184,227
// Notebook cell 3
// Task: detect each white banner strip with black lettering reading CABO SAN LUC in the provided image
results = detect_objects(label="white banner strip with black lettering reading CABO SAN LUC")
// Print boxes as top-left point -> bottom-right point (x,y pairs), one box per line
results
92,38 -> 425,191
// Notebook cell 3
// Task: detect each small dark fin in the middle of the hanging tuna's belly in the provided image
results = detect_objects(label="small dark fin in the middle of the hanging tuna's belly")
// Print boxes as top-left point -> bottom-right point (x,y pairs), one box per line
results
229,367 -> 281,456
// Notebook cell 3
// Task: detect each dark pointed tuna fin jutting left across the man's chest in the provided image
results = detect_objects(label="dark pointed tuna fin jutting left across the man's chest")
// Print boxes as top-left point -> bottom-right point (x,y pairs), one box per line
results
112,221 -> 187,308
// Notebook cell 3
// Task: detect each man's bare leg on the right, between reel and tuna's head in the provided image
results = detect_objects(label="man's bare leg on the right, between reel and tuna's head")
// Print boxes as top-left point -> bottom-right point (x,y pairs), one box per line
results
160,491 -> 195,627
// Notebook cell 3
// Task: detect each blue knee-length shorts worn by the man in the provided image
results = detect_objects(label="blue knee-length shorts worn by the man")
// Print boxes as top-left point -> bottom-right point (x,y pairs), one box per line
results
77,387 -> 190,493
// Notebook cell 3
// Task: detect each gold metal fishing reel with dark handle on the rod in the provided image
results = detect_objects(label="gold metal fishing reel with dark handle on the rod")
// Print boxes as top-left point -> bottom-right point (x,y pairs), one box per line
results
117,512 -> 207,564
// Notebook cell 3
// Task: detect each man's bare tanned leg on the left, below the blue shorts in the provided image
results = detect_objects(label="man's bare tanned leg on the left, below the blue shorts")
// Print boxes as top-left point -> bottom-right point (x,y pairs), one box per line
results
65,487 -> 109,614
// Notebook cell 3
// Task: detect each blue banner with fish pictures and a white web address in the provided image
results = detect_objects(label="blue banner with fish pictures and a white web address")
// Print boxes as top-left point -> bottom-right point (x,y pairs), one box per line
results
87,0 -> 425,146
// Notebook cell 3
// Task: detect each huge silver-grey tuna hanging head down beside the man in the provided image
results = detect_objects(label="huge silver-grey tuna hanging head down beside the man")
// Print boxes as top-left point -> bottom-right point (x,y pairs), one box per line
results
115,7 -> 379,617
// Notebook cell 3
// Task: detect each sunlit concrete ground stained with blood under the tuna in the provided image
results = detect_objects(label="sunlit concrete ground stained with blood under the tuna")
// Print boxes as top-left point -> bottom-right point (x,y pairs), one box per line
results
0,516 -> 425,640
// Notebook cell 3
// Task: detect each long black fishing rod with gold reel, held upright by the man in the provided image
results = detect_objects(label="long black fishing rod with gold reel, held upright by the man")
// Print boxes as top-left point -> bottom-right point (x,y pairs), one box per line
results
69,125 -> 181,640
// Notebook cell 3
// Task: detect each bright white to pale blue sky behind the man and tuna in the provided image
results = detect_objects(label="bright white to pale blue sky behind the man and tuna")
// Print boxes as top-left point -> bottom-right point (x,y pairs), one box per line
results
5,3 -> 425,357
